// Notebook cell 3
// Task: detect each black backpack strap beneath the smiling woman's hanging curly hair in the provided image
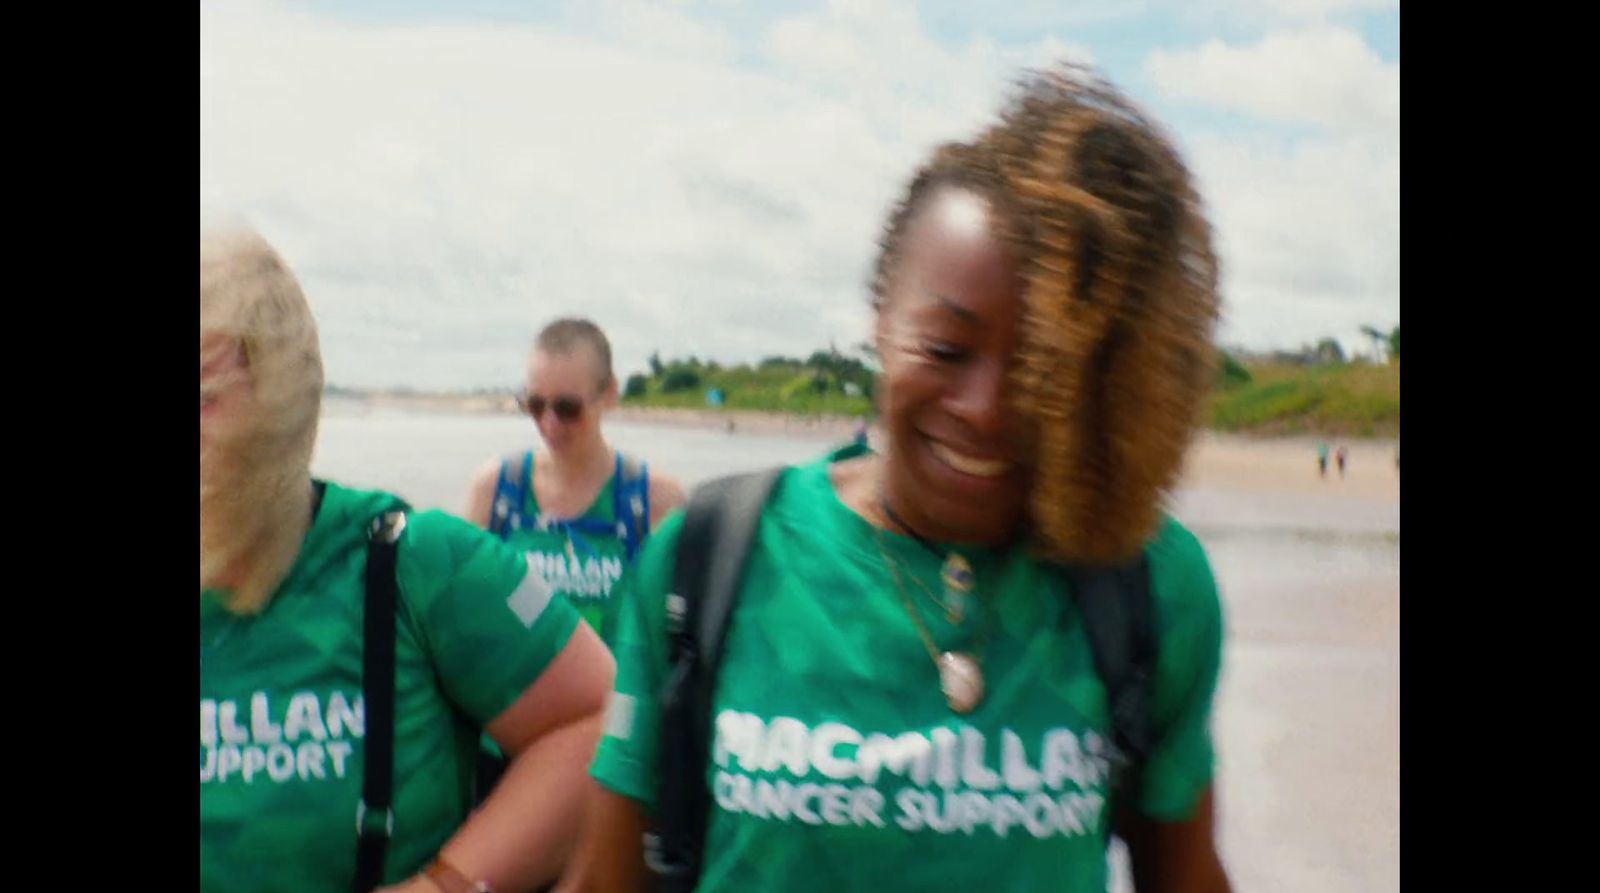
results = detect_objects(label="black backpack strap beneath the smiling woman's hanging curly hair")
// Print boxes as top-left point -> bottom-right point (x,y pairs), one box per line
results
1064,554 -> 1160,838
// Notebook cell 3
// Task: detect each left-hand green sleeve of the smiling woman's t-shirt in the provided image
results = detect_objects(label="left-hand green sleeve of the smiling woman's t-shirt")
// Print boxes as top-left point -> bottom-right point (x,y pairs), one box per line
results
589,512 -> 683,807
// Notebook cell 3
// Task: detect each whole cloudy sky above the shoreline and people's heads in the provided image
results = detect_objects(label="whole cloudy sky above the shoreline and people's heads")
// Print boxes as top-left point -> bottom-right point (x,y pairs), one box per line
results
200,0 -> 1400,389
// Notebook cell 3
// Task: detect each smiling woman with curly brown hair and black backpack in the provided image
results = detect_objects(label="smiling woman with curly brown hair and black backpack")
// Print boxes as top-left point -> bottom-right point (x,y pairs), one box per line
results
558,67 -> 1229,893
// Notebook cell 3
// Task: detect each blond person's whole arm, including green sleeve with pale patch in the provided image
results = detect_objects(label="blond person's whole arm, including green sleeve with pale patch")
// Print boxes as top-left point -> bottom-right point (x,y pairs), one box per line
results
376,512 -> 616,893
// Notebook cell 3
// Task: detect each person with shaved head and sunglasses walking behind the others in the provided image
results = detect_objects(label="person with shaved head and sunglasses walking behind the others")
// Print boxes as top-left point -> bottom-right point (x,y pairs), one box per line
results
467,318 -> 683,637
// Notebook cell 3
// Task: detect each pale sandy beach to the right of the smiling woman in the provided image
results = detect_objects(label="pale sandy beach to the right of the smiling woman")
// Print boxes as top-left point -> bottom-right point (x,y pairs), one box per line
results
1179,435 -> 1400,893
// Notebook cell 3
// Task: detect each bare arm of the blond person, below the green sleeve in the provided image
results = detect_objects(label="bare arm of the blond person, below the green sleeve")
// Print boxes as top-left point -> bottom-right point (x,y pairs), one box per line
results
425,624 -> 617,893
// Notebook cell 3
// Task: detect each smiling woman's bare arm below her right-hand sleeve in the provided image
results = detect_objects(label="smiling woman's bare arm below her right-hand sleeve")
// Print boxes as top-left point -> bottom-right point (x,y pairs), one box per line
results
1118,787 -> 1234,893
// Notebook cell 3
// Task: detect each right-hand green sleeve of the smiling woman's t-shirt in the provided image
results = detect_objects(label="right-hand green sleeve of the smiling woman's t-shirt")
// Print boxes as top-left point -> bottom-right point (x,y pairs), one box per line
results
1139,519 -> 1222,821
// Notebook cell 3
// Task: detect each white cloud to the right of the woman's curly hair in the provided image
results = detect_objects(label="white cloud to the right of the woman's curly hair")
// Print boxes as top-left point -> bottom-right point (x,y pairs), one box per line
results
1146,26 -> 1400,352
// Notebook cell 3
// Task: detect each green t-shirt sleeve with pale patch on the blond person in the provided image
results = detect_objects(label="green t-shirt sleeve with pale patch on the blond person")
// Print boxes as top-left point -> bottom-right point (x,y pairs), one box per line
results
397,512 -> 578,725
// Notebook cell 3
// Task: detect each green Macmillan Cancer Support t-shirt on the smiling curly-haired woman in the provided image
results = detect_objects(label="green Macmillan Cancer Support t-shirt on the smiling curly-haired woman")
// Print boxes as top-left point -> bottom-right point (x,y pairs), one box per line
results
592,456 -> 1222,893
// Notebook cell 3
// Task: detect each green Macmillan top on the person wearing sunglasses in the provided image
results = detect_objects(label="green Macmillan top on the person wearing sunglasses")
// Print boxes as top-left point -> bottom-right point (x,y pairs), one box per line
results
492,461 -> 627,637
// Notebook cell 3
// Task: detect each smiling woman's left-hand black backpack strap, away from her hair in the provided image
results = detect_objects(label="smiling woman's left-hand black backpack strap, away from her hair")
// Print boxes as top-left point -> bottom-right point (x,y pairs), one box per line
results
645,469 -> 782,893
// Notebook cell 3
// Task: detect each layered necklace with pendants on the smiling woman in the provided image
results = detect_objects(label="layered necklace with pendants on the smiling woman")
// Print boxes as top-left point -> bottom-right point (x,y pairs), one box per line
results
872,491 -> 989,714
